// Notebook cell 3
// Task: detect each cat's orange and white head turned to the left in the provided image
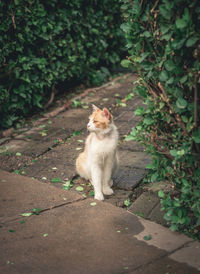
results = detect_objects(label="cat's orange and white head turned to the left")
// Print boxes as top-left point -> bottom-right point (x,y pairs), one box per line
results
87,105 -> 113,133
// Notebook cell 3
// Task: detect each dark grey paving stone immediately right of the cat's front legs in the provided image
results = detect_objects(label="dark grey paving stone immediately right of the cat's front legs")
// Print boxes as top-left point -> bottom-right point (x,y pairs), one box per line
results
113,166 -> 147,190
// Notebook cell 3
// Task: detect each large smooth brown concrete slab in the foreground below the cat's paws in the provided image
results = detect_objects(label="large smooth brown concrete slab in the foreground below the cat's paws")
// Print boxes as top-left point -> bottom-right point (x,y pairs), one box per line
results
0,199 -> 166,274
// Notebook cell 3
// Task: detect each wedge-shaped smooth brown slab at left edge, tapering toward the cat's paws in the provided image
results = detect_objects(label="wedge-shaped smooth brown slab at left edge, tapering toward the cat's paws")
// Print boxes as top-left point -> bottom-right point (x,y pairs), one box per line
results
0,170 -> 82,224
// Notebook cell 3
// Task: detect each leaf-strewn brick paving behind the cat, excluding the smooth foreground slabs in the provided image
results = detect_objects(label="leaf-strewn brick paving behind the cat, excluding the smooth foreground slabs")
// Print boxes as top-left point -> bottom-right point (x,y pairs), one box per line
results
0,75 -> 150,207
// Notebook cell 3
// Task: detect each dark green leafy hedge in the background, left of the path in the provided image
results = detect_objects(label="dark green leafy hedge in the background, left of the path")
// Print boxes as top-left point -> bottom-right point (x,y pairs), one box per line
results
0,0 -> 124,127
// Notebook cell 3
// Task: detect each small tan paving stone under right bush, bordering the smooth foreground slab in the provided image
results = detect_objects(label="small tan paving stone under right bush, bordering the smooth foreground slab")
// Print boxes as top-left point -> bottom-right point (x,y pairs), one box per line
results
128,192 -> 160,218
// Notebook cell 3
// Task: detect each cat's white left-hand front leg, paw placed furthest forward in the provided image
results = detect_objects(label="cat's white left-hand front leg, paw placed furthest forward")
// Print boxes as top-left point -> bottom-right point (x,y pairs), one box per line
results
91,165 -> 104,201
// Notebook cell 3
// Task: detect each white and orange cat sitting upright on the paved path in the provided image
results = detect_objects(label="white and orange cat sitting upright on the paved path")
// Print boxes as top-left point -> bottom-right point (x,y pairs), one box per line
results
76,105 -> 118,200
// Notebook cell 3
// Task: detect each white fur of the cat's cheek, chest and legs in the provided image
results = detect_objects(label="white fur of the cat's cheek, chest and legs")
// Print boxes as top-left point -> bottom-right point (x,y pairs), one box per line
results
78,119 -> 118,200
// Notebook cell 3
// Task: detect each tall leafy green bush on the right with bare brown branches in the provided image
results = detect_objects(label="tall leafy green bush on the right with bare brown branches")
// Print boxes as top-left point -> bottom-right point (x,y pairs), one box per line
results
121,0 -> 200,239
